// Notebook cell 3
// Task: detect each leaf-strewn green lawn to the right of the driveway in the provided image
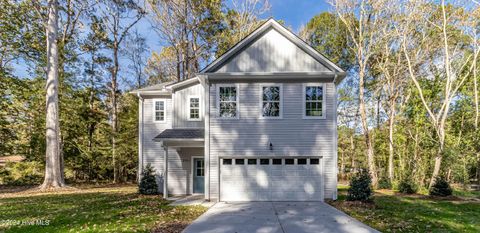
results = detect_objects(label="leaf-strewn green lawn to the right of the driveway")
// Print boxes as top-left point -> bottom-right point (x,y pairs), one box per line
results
330,186 -> 480,232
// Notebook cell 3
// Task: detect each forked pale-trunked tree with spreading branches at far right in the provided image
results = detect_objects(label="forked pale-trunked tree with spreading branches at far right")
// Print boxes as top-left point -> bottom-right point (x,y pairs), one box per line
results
397,0 -> 478,187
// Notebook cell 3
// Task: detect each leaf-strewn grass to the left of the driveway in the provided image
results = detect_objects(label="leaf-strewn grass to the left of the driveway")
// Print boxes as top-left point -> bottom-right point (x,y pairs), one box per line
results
0,186 -> 206,232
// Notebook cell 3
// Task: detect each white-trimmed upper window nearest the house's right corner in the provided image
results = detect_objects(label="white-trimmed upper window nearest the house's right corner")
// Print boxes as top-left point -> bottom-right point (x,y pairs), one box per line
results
302,83 -> 326,119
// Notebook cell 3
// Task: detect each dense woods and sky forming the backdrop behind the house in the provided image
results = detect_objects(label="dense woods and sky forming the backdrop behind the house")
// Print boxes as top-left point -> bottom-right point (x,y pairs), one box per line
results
0,0 -> 480,191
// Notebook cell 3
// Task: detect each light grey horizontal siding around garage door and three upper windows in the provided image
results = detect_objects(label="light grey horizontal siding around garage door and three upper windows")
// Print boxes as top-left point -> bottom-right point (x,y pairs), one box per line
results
210,82 -> 337,198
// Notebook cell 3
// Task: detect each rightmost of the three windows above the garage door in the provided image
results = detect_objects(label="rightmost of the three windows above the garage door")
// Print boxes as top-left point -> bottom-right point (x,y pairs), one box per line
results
303,85 -> 325,118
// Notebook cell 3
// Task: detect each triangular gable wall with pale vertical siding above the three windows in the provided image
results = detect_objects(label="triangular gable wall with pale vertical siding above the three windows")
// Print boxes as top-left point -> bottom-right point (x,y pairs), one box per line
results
216,29 -> 330,72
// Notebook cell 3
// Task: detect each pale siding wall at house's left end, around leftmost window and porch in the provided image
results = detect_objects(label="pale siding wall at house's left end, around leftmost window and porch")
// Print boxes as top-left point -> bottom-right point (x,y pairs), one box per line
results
142,96 -> 204,195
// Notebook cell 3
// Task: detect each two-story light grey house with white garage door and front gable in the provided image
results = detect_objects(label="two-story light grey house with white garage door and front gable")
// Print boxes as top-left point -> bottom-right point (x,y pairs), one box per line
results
134,19 -> 345,201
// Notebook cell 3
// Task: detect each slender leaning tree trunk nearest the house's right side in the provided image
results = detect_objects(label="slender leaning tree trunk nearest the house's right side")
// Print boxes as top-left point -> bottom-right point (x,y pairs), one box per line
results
358,69 -> 378,187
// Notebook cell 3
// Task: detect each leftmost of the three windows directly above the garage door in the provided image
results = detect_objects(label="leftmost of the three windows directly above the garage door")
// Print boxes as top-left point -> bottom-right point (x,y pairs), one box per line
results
217,85 -> 238,118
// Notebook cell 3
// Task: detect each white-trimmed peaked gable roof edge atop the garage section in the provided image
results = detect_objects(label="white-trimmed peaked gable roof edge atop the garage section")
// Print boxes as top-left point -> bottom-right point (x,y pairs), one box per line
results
200,18 -> 345,76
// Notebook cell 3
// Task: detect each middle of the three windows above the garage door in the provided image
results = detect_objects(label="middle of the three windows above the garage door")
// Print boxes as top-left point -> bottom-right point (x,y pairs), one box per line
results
261,85 -> 282,118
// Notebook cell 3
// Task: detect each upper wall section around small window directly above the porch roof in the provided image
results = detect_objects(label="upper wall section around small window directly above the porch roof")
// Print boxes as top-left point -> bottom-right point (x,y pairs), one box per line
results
173,83 -> 205,128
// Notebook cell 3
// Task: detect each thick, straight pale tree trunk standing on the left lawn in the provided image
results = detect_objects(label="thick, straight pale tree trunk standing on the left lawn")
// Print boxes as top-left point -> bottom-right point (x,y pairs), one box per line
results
40,0 -> 65,189
